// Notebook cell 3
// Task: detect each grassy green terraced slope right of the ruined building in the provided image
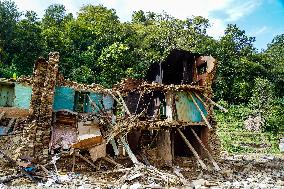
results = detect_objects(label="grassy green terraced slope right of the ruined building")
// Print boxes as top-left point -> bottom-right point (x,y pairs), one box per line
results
215,101 -> 284,154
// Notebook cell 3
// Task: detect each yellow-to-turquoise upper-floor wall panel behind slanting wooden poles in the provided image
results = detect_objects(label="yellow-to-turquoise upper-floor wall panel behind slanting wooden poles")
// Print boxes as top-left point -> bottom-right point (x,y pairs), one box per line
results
175,92 -> 208,122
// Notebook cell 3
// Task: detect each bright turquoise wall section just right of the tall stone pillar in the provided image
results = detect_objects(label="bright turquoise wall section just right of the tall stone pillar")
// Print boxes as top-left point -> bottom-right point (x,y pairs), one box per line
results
53,87 -> 75,111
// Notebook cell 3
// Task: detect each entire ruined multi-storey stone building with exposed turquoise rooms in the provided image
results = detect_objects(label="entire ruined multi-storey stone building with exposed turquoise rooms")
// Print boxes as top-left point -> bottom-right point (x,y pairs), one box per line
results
0,50 -> 226,186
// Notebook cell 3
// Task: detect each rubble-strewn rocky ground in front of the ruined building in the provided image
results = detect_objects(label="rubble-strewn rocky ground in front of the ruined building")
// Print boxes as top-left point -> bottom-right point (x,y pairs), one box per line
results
0,155 -> 284,189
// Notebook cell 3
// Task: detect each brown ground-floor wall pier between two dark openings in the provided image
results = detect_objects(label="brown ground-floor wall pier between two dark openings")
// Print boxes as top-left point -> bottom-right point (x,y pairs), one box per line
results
157,129 -> 173,166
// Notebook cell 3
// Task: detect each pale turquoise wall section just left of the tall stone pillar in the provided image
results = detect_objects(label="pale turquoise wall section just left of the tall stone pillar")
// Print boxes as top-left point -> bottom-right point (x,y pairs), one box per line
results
14,83 -> 32,109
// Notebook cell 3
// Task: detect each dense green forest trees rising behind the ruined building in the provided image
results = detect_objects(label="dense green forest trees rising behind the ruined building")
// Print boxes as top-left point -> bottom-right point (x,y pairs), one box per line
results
0,1 -> 284,151
